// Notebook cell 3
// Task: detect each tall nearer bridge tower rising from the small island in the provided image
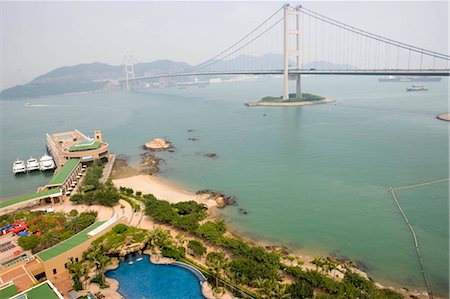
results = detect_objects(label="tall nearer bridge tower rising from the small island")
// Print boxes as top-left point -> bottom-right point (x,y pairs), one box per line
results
283,4 -> 302,101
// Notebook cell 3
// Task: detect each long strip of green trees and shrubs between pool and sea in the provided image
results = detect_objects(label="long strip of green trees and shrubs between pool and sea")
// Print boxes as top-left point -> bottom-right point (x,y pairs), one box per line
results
110,195 -> 402,298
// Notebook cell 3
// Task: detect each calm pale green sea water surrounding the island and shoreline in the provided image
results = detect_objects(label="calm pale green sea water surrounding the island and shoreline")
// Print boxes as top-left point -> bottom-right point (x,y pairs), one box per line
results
0,76 -> 449,297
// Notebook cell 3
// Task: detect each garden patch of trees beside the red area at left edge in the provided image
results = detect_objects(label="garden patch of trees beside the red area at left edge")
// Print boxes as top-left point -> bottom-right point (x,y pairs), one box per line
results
0,211 -> 97,253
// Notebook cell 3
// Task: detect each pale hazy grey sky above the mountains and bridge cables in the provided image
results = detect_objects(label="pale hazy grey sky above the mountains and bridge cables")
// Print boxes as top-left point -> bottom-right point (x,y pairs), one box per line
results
0,1 -> 448,89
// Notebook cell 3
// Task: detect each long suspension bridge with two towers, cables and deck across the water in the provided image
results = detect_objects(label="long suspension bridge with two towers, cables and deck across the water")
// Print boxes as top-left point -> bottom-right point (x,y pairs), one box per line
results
123,4 -> 450,100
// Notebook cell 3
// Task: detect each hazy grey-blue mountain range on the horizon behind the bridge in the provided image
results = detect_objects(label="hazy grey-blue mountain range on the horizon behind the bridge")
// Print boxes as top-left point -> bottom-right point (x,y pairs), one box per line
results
0,54 -> 354,99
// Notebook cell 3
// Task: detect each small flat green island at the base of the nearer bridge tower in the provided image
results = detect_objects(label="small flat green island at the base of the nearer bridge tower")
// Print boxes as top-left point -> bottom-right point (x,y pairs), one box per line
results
245,93 -> 335,107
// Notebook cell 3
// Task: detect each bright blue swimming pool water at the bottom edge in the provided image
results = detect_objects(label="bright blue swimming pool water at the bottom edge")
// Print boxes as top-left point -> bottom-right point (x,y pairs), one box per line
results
106,255 -> 205,299
